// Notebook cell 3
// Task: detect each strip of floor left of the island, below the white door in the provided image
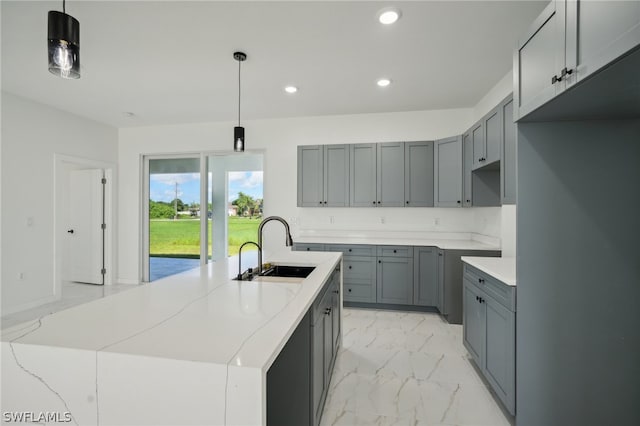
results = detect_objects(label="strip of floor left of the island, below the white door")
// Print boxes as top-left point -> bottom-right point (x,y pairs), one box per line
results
0,282 -> 137,330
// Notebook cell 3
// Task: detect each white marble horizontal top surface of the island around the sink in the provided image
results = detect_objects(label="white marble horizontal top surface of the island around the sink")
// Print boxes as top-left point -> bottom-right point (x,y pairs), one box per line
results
2,249 -> 341,370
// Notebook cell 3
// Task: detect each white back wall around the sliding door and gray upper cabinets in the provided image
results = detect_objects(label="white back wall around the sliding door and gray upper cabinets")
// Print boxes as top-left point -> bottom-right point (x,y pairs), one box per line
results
118,109 -> 492,282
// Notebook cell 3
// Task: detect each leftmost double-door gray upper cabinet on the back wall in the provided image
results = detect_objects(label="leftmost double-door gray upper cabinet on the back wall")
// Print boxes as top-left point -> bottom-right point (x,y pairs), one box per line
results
298,145 -> 349,207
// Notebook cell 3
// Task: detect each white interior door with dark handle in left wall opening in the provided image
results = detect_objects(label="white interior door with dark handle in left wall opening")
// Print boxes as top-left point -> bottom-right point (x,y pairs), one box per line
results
65,169 -> 104,284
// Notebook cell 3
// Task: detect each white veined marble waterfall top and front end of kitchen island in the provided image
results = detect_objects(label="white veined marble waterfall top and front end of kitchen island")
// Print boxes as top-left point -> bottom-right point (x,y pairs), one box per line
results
2,251 -> 342,425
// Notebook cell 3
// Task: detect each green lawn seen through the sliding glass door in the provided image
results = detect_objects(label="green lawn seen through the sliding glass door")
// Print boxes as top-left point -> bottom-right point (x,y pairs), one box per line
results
149,217 -> 260,257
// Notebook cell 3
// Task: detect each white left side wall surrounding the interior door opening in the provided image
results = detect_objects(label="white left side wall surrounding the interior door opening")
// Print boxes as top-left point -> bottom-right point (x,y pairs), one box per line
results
1,92 -> 118,315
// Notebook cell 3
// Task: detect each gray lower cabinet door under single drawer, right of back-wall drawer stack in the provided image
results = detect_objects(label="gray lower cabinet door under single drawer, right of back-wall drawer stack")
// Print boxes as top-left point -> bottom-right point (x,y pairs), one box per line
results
377,257 -> 413,305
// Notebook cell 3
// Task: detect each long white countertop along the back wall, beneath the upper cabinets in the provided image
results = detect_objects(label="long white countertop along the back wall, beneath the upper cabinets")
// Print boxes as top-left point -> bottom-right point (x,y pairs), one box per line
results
294,233 -> 500,250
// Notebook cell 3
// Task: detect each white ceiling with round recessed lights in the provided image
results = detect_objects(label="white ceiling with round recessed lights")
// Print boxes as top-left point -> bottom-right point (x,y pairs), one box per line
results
2,0 -> 547,127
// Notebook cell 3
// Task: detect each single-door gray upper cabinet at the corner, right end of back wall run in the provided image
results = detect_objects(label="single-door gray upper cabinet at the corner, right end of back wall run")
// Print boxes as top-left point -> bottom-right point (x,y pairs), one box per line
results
433,136 -> 462,207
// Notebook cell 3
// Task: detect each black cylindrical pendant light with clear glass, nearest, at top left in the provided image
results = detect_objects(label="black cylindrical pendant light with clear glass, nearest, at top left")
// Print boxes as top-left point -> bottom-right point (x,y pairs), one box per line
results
47,0 -> 80,78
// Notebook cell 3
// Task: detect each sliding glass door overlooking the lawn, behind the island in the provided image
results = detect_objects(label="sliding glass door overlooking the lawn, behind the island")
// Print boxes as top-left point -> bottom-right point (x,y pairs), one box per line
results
142,153 -> 264,281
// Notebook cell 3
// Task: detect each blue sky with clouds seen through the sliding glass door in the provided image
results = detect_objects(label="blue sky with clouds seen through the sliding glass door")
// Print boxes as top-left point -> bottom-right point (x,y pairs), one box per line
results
149,171 -> 263,204
